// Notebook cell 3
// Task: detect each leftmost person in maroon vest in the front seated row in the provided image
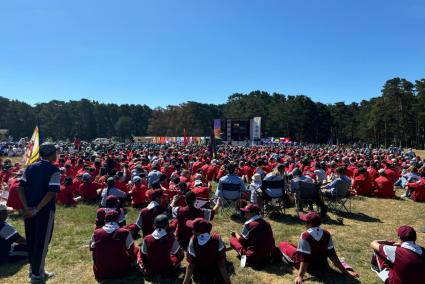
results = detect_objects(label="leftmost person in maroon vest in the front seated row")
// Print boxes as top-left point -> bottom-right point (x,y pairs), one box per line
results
90,210 -> 139,279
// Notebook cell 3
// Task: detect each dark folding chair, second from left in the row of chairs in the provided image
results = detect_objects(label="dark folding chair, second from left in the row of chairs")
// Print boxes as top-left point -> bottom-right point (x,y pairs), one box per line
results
260,179 -> 286,215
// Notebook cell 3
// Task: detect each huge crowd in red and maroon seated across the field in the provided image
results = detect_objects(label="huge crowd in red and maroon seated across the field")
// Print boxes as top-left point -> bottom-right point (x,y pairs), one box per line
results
0,144 -> 425,283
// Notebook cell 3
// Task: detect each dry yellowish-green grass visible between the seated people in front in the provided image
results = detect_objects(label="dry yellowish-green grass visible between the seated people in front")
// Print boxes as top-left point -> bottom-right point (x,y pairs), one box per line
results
0,187 -> 425,284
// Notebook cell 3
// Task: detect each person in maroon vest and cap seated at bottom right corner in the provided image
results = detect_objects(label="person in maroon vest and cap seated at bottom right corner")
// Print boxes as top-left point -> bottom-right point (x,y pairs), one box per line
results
370,226 -> 425,284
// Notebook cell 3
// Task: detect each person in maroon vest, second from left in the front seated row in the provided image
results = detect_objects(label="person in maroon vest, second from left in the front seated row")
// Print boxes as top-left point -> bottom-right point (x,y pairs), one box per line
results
138,215 -> 184,276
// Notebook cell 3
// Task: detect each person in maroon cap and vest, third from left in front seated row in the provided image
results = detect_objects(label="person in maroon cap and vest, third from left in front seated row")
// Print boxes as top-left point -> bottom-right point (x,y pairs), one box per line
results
183,218 -> 230,284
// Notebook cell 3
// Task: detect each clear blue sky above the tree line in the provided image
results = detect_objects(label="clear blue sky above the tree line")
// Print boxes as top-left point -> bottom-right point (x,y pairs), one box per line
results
0,0 -> 425,107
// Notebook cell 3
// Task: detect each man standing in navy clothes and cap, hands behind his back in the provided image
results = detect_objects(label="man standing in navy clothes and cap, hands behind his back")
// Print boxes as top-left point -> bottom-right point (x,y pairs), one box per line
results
19,143 -> 60,283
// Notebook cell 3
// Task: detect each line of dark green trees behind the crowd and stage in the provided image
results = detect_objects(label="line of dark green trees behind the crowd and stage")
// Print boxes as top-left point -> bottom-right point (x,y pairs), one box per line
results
0,78 -> 425,148
